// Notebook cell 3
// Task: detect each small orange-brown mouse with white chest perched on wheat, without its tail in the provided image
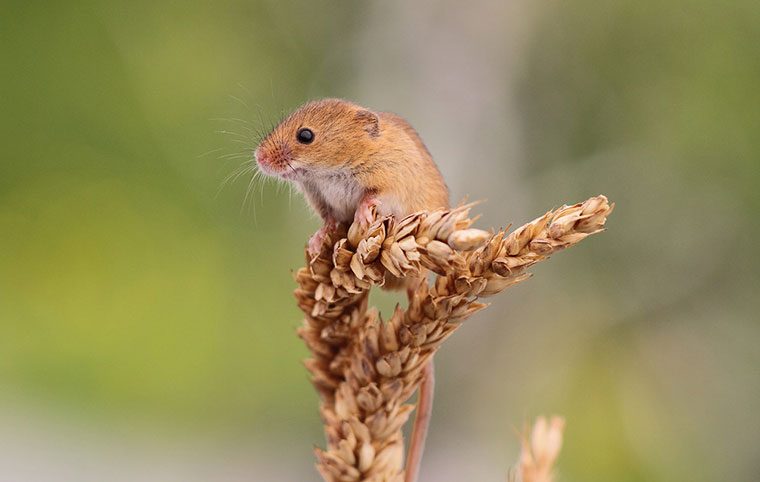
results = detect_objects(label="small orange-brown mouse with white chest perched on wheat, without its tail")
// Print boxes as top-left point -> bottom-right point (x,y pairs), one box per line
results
255,99 -> 449,253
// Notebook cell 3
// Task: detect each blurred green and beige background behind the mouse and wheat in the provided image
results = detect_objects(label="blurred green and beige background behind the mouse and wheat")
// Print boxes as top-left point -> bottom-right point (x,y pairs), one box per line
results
0,0 -> 760,482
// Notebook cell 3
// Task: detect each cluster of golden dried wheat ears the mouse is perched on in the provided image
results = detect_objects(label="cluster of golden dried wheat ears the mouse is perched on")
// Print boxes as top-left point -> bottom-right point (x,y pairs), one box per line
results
295,196 -> 613,481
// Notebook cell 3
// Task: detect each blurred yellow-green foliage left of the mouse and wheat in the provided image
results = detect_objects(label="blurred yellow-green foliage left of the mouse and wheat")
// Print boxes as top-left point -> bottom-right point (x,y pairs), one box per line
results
0,1 -> 366,431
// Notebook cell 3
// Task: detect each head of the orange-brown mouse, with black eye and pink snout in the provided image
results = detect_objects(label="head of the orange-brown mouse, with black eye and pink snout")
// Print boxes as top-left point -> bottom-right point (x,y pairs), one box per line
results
255,99 -> 380,180
